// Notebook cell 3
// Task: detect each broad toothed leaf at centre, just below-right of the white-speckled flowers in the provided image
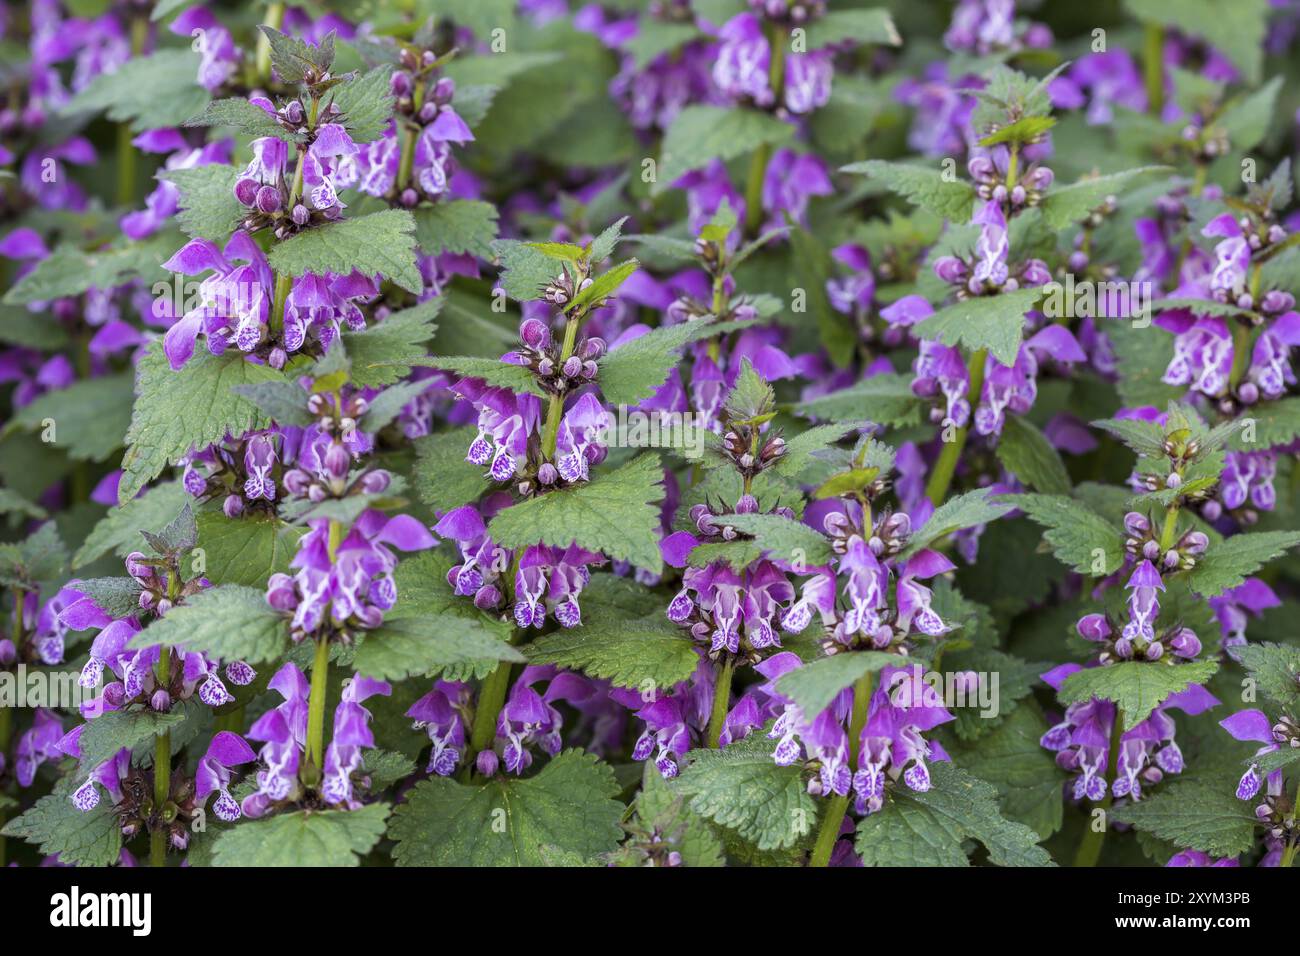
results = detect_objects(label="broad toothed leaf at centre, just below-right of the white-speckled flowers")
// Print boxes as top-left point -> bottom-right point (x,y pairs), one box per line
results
525,574 -> 699,689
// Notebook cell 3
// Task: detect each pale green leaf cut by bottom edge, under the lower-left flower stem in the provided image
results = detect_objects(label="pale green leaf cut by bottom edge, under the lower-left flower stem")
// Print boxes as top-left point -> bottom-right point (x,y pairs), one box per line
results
212,804 -> 391,868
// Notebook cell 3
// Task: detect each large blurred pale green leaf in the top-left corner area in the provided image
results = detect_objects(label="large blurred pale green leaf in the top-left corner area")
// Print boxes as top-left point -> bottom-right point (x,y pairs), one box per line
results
60,49 -> 209,133
